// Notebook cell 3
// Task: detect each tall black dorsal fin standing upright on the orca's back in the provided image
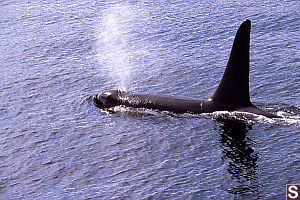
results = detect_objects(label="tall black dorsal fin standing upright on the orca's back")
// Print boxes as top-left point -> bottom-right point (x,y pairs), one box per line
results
211,20 -> 252,107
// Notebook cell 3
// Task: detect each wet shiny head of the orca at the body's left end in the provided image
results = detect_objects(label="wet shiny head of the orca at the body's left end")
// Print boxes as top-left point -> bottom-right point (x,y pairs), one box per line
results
93,90 -> 120,108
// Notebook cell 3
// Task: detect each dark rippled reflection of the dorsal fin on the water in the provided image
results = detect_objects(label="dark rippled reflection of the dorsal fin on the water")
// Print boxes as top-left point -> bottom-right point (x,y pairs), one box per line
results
218,119 -> 261,198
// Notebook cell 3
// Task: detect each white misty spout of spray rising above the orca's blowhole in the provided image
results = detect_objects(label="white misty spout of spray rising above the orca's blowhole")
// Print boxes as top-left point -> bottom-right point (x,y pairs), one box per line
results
97,4 -> 146,91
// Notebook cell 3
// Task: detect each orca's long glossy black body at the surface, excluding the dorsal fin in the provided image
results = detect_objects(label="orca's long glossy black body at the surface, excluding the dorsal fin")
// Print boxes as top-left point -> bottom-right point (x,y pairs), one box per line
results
94,90 -> 279,118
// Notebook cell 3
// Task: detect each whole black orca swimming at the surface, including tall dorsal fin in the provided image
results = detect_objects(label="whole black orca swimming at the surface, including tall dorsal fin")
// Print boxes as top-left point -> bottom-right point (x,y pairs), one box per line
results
93,20 -> 279,118
